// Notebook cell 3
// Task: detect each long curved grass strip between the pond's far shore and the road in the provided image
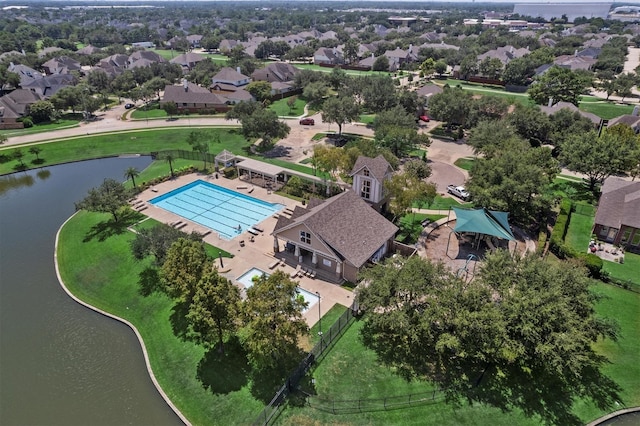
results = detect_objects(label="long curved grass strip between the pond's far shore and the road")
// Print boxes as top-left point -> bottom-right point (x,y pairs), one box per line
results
0,128 -> 249,174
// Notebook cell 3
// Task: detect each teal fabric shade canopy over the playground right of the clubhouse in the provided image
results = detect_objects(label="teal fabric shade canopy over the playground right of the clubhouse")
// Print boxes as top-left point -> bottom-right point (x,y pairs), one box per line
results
453,207 -> 516,241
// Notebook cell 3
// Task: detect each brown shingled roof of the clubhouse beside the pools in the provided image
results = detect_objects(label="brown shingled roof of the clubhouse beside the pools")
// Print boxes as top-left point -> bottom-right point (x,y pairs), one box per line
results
273,191 -> 398,268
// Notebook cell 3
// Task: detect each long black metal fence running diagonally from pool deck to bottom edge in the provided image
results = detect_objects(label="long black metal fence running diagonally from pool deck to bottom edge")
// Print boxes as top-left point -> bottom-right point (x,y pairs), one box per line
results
253,304 -> 357,425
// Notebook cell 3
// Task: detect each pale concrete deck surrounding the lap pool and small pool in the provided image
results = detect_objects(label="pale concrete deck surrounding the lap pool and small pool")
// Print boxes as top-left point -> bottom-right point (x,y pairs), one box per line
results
135,173 -> 354,326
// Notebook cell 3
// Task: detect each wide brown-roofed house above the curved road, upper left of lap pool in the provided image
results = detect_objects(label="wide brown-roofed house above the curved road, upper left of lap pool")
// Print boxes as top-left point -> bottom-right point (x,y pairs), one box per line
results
160,80 -> 229,112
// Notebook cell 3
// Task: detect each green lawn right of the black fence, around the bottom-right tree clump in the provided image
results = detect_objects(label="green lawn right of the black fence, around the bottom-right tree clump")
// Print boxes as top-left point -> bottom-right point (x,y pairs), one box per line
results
279,283 -> 640,425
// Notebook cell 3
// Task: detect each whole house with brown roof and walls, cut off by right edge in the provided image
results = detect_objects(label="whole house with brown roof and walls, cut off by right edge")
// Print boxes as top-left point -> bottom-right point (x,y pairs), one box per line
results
593,177 -> 640,253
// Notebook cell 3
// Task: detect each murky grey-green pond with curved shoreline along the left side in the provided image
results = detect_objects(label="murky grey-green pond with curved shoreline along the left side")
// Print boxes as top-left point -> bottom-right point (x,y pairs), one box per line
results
0,157 -> 182,425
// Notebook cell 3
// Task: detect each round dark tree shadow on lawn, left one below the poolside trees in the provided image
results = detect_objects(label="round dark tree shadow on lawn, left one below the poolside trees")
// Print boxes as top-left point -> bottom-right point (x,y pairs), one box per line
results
196,337 -> 251,394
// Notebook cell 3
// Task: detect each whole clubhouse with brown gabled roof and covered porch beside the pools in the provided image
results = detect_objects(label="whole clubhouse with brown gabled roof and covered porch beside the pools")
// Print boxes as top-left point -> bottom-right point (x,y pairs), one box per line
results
272,191 -> 398,282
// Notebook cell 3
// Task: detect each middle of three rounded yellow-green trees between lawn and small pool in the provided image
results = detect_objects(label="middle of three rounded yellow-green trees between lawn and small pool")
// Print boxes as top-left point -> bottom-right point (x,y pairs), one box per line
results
187,267 -> 241,353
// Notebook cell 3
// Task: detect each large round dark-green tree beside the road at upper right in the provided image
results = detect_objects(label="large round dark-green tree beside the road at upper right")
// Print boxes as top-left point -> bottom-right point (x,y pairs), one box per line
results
529,65 -> 586,106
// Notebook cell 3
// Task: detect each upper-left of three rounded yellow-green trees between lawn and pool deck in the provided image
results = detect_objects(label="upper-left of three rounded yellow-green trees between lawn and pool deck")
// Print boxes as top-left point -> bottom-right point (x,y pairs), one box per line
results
160,238 -> 207,303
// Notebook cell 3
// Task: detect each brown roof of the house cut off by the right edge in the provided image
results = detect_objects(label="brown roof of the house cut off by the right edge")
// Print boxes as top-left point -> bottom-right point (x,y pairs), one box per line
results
595,177 -> 640,229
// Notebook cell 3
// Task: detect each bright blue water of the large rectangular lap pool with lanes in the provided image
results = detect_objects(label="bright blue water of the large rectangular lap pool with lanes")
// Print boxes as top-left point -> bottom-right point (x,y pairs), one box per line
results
150,180 -> 283,240
